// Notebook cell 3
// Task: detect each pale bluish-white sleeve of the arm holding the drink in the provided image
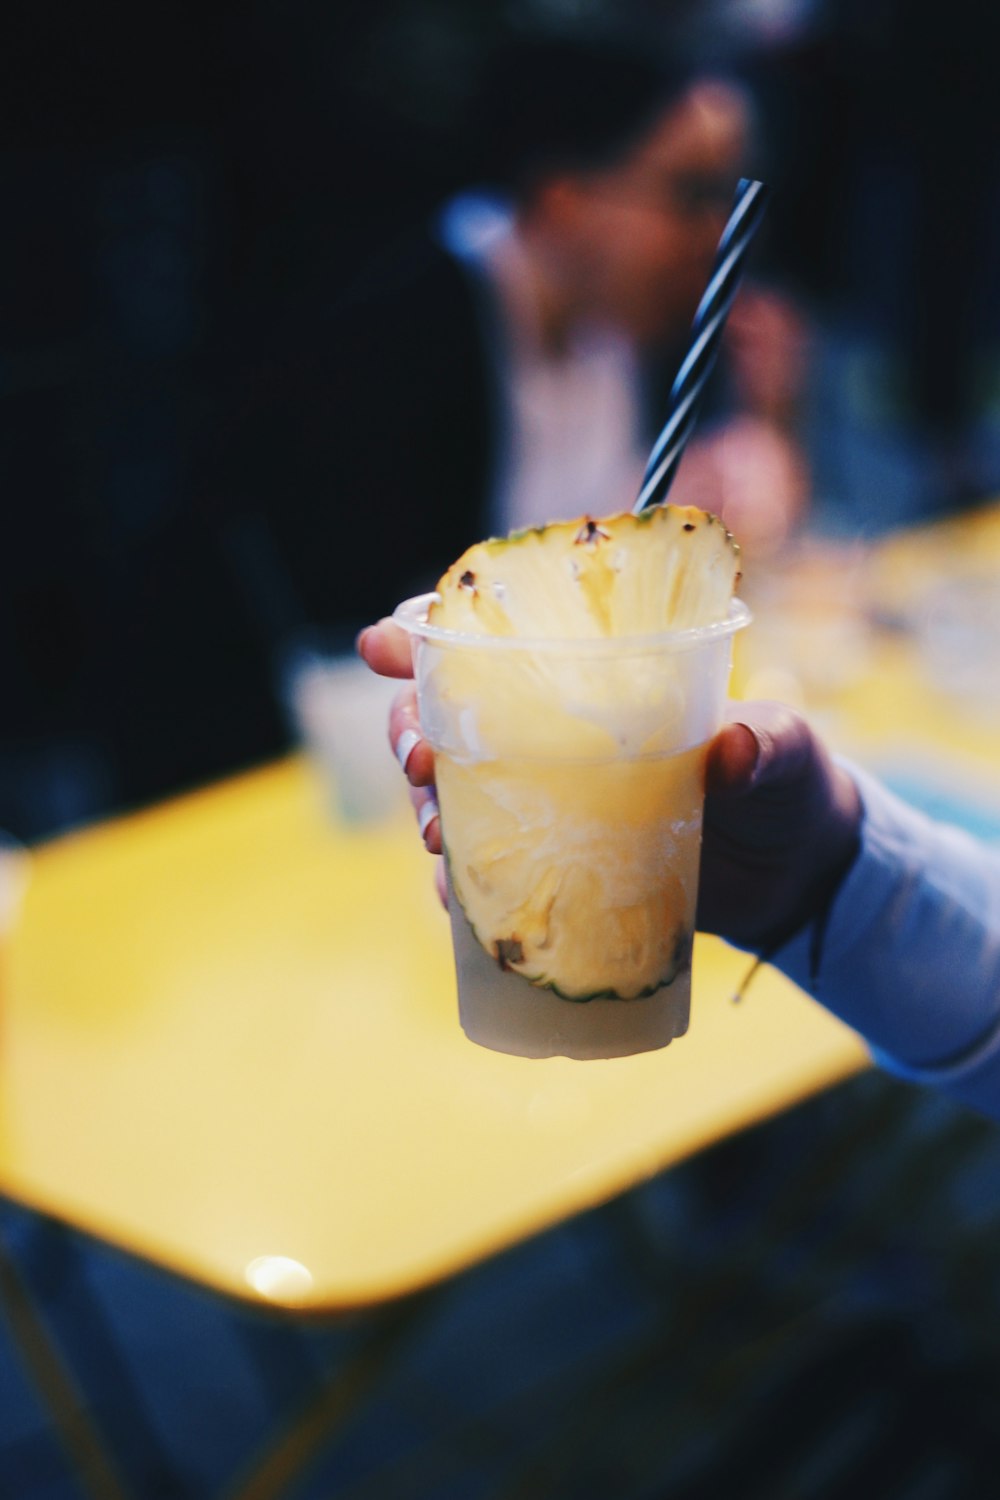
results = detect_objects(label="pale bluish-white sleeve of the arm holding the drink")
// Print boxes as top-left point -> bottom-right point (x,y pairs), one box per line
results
772,765 -> 1000,1119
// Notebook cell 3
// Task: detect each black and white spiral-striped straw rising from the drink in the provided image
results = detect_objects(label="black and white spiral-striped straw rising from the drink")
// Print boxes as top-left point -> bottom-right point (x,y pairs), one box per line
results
634,177 -> 769,515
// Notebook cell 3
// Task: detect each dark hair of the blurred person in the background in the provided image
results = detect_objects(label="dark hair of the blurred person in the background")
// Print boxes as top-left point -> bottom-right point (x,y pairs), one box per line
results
477,32 -> 694,197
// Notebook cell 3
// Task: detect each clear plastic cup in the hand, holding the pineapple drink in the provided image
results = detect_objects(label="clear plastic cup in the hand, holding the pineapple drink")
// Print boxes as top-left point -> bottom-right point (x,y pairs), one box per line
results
394,594 -> 750,1058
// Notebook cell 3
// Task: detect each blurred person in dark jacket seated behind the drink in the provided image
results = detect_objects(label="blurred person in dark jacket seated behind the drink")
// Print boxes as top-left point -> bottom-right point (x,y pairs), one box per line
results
217,24 -> 807,645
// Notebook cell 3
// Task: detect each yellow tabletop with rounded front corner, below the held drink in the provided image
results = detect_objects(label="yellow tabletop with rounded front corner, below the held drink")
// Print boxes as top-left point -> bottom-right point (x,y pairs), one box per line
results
0,759 -> 865,1311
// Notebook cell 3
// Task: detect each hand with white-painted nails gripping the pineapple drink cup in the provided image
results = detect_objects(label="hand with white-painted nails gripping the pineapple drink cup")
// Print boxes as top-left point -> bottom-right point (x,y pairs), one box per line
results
358,620 -> 861,950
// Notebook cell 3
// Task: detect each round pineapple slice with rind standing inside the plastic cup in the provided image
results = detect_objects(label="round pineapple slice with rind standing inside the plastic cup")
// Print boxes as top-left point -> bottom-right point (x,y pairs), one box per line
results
429,506 -> 739,1001
